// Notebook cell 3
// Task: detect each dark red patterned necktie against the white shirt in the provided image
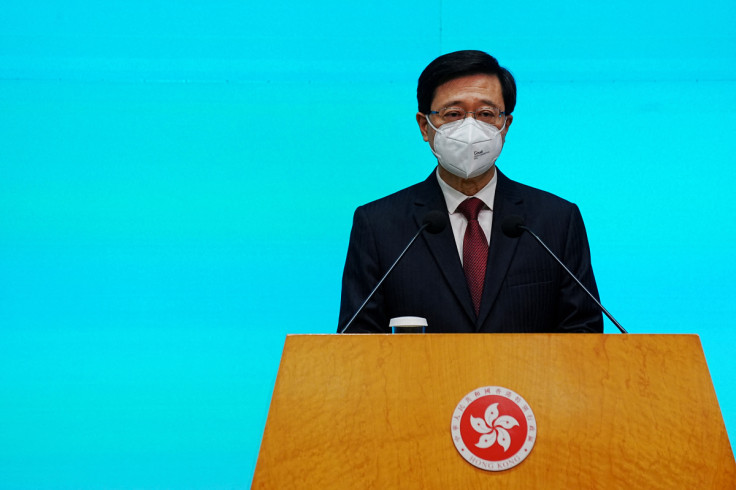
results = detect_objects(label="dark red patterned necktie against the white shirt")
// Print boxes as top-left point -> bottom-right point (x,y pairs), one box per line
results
457,197 -> 488,315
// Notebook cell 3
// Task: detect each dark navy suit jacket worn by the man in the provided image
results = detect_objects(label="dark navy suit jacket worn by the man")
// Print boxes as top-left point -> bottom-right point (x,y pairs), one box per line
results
338,169 -> 603,333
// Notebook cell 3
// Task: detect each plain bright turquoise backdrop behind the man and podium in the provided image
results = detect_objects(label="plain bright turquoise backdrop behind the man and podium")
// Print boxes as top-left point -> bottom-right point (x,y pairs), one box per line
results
0,0 -> 736,489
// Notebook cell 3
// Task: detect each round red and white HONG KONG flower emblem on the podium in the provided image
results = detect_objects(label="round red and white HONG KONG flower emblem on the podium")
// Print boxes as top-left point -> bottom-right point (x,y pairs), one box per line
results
451,386 -> 537,471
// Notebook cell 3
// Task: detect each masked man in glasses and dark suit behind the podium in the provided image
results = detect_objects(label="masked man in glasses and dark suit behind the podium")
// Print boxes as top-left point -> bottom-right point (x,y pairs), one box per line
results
338,51 -> 603,333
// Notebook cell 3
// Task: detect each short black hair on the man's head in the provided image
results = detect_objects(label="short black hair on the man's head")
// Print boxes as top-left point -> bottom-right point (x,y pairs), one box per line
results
417,50 -> 516,114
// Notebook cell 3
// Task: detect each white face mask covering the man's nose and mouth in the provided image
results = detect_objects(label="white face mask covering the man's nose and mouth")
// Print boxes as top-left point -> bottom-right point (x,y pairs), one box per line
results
427,117 -> 505,179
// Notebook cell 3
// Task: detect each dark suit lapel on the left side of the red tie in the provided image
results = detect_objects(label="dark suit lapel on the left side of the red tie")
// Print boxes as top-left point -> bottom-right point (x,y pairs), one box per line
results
414,172 -> 476,323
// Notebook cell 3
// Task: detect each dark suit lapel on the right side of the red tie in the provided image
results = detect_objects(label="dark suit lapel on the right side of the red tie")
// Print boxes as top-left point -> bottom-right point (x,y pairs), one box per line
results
476,168 -> 525,330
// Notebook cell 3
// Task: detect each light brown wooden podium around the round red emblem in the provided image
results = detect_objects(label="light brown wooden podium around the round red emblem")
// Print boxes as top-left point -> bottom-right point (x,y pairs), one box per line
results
253,334 -> 736,490
